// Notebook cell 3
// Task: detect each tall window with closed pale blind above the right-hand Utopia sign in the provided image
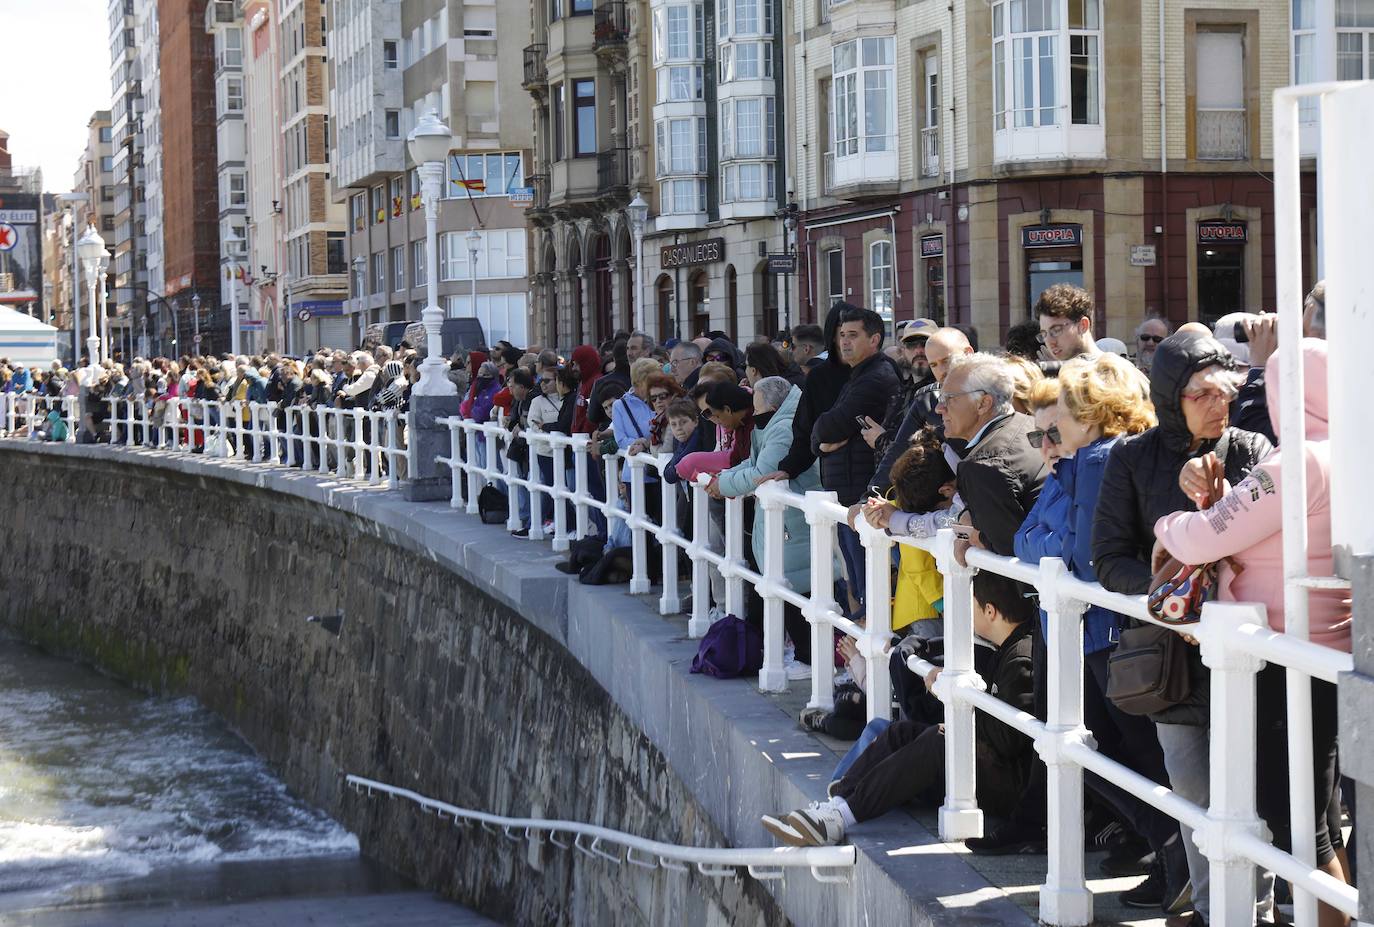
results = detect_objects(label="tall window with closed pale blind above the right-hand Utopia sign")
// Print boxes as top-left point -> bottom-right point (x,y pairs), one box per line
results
1193,30 -> 1249,161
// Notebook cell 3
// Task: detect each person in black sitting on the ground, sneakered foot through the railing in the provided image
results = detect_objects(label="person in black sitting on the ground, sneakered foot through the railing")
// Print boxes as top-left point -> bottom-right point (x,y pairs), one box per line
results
763,571 -> 1036,846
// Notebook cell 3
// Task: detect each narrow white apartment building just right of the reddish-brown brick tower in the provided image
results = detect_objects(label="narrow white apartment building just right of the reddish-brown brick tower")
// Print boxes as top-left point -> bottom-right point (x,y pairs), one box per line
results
205,0 -> 255,352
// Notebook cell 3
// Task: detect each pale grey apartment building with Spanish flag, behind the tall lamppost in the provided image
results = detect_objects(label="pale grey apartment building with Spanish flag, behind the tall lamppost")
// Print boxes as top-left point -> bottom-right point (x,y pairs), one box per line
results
331,0 -> 537,350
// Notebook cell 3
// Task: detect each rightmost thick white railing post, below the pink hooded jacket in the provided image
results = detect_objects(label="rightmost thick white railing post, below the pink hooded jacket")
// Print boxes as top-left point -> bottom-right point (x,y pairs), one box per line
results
1193,602 -> 1272,924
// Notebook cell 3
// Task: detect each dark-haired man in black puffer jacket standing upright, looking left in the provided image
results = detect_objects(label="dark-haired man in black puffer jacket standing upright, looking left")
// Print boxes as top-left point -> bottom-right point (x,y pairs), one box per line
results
811,306 -> 901,603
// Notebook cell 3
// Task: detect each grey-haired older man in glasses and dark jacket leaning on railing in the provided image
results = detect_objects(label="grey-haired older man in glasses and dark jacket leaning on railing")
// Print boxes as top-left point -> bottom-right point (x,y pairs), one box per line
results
936,354 -> 1044,558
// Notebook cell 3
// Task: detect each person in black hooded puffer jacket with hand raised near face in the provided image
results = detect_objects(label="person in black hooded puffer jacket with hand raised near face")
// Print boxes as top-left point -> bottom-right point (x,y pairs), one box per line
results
1092,331 -> 1271,917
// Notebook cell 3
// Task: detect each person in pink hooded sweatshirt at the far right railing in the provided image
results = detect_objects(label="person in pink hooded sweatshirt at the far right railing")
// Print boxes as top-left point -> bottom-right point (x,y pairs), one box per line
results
1154,338 -> 1351,923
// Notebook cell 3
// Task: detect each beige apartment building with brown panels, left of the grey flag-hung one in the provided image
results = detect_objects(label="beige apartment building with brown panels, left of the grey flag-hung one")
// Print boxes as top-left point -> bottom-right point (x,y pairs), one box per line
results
276,0 -> 348,349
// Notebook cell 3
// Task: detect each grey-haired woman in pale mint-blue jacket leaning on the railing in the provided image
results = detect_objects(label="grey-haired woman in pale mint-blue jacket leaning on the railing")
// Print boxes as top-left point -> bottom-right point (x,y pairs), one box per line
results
712,376 -> 820,663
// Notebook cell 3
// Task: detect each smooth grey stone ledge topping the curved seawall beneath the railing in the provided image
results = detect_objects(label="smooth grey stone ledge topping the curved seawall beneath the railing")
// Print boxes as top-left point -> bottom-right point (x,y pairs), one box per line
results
0,441 -> 1033,927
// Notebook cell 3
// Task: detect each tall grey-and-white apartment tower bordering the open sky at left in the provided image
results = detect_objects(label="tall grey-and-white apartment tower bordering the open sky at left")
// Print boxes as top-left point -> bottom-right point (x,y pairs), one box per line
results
106,0 -> 148,339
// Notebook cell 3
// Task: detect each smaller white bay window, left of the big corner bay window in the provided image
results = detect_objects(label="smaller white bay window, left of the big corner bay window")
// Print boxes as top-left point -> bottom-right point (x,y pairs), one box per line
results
830,37 -> 897,184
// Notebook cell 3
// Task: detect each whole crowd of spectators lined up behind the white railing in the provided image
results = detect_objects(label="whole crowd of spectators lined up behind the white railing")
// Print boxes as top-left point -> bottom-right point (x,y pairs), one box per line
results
0,284 -> 1353,926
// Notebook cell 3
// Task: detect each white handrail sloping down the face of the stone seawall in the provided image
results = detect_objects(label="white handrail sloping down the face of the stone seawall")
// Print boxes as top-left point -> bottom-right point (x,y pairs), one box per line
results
345,775 -> 857,883
